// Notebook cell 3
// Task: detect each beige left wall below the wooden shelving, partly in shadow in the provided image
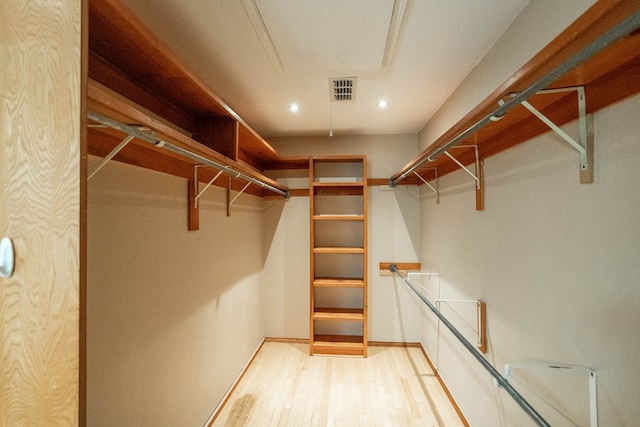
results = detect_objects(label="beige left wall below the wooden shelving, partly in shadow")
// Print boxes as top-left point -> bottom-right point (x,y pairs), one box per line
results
87,159 -> 264,427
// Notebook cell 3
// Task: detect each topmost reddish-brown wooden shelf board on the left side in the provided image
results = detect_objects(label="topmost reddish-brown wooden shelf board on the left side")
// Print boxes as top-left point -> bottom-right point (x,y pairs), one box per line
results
89,0 -> 282,170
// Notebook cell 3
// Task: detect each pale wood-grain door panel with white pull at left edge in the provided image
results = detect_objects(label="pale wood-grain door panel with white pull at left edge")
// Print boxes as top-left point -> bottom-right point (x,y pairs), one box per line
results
0,0 -> 83,426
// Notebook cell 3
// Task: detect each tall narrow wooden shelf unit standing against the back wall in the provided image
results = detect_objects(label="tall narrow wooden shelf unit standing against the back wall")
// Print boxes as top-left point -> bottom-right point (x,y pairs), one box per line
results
309,156 -> 368,357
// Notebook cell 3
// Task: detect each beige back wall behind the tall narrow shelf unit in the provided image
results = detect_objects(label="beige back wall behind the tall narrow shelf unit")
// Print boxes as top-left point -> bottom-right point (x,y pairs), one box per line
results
264,135 -> 420,342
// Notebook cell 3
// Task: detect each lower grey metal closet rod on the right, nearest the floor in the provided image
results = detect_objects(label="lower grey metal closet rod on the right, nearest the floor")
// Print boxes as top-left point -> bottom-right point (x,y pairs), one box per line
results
389,264 -> 550,427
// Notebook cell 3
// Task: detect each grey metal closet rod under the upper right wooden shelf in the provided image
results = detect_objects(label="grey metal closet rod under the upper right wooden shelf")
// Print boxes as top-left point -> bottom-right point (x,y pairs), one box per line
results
389,10 -> 640,188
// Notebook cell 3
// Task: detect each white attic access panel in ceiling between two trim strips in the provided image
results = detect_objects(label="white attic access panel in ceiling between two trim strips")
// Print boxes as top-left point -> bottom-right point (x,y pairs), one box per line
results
243,0 -> 405,74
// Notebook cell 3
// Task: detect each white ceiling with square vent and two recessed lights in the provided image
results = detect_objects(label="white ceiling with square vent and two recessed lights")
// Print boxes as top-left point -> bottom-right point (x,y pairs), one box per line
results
122,0 -> 529,138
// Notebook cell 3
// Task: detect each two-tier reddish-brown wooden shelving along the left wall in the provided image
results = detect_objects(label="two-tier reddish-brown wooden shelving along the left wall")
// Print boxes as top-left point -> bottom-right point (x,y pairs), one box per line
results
87,0 -> 308,204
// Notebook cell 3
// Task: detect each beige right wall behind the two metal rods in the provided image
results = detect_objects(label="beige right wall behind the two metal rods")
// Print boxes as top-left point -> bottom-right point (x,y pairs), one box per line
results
420,1 -> 640,426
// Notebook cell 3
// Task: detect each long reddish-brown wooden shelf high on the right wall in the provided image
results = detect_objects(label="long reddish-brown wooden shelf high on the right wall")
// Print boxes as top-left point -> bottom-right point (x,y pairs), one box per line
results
390,0 -> 640,185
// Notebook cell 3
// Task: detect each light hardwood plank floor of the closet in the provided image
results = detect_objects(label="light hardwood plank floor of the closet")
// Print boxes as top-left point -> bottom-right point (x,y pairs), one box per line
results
213,342 -> 463,427
